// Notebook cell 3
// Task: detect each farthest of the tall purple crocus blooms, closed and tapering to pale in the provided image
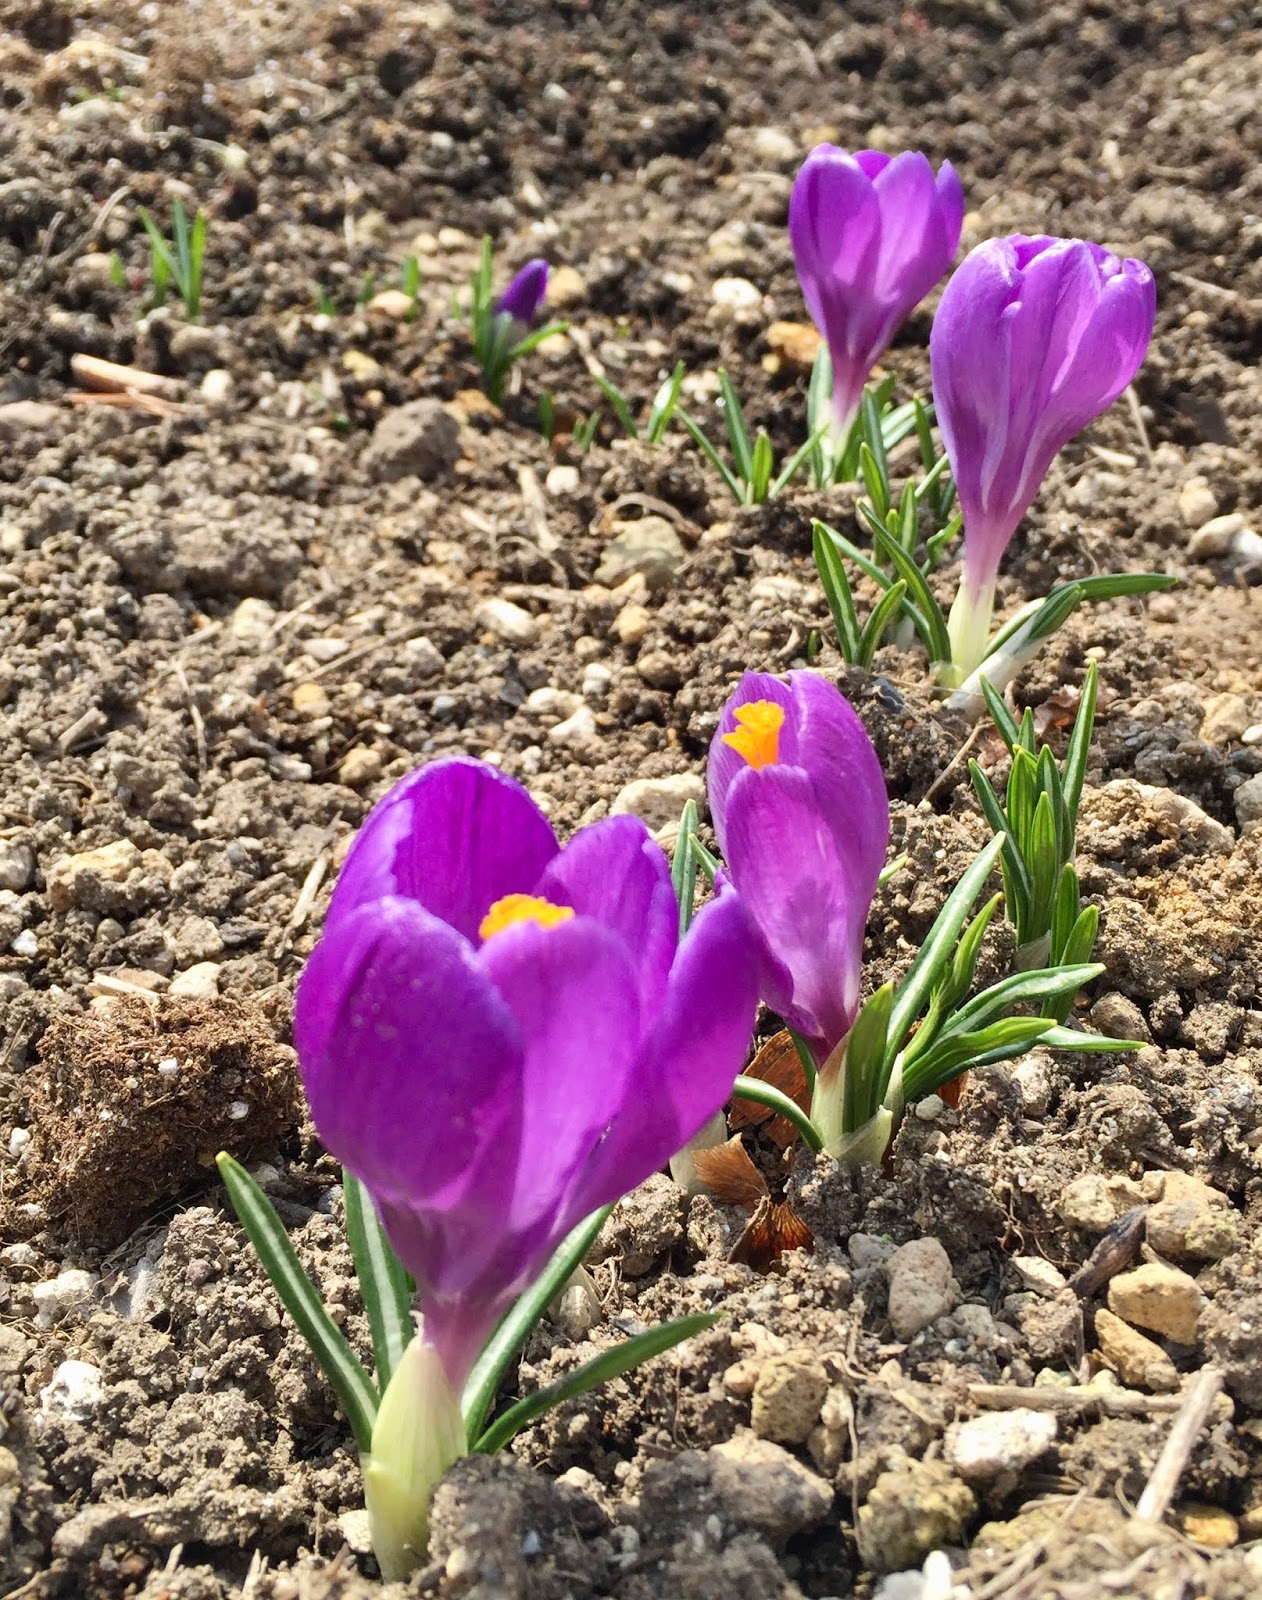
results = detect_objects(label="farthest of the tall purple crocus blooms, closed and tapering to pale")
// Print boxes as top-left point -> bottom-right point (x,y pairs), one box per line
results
789,144 -> 964,442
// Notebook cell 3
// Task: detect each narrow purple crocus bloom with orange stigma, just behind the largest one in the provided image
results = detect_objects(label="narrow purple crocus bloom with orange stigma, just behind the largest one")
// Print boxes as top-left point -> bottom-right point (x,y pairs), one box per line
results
709,672 -> 889,1062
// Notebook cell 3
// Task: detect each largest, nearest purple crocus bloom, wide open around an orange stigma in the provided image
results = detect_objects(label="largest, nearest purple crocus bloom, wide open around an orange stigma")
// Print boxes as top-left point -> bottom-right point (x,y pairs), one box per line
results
294,757 -> 758,1394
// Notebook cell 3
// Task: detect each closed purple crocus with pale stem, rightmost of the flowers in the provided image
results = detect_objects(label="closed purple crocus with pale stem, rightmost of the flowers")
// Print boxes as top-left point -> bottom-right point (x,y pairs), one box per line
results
929,234 -> 1156,677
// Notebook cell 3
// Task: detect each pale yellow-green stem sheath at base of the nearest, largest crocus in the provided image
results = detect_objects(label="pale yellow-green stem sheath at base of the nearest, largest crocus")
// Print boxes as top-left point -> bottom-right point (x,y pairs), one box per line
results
363,1339 -> 469,1584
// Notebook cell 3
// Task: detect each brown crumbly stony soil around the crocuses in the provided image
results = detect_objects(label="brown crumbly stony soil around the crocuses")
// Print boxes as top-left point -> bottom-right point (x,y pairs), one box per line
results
0,0 -> 1262,1600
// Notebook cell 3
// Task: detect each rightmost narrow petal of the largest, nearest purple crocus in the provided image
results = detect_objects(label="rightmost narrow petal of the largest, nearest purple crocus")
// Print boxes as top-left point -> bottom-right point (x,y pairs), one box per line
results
571,893 -> 758,1221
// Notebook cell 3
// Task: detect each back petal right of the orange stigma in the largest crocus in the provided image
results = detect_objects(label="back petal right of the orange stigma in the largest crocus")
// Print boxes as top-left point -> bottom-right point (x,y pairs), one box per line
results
536,816 -> 680,1014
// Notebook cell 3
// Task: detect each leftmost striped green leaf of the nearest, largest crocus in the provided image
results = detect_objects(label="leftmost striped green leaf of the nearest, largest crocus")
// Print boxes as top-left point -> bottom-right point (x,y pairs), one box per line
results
216,1150 -> 377,1451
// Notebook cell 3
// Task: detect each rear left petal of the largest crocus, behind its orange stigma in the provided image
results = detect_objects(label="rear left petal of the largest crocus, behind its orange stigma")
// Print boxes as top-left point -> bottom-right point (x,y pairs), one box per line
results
325,755 -> 557,942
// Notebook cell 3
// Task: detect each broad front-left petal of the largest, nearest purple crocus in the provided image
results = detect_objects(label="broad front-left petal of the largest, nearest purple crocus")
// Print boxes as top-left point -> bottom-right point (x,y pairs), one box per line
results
294,899 -> 523,1248
